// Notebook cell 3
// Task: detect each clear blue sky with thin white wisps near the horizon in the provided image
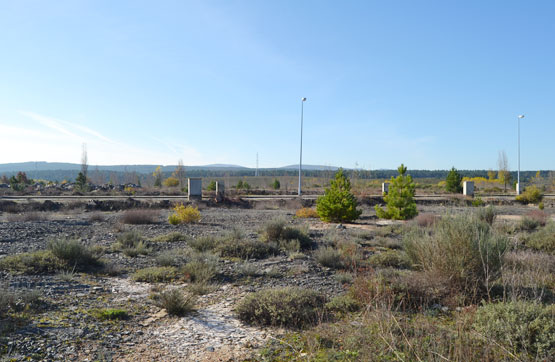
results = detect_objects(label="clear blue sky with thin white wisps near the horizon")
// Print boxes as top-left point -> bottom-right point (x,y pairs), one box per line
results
0,0 -> 555,170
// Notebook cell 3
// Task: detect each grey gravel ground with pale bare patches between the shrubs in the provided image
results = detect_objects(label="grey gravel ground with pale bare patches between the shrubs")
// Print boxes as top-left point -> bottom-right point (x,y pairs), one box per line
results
0,205 -> 555,361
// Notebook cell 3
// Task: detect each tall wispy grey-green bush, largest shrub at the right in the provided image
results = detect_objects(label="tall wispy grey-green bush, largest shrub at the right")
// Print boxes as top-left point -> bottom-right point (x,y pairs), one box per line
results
404,215 -> 508,299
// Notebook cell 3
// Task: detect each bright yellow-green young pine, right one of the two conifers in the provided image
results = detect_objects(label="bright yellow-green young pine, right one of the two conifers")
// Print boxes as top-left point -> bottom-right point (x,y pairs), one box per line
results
375,164 -> 418,220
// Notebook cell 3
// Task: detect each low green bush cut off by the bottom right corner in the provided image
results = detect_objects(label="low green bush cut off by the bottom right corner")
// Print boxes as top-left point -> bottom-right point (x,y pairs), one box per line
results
474,302 -> 555,360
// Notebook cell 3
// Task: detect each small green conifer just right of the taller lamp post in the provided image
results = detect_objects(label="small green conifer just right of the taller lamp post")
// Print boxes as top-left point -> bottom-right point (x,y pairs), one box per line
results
316,169 -> 362,222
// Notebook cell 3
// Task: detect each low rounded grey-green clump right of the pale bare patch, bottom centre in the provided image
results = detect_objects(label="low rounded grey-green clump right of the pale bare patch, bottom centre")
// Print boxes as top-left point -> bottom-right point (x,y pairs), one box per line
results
236,287 -> 326,328
